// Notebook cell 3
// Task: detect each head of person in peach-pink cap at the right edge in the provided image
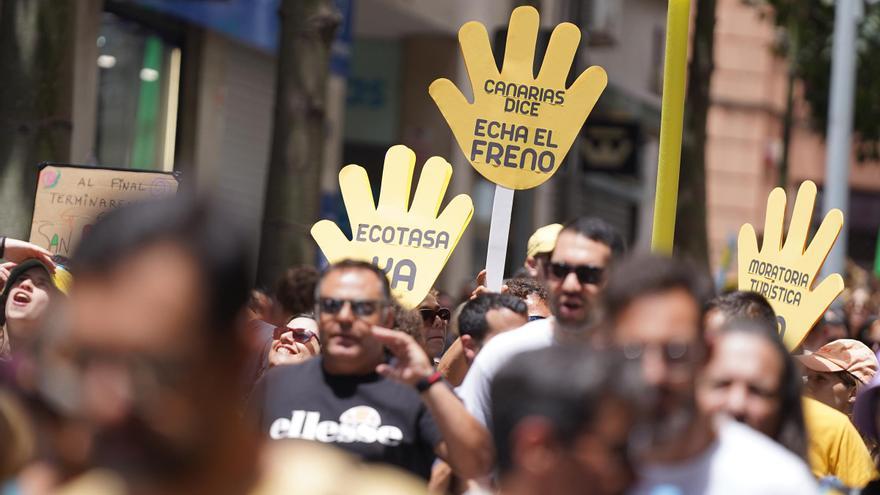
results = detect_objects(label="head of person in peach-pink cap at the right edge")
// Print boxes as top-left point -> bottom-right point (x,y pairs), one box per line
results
795,339 -> 878,416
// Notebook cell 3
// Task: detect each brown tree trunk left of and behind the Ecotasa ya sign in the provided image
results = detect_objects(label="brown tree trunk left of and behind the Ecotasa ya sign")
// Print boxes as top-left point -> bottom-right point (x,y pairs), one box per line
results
258,0 -> 341,284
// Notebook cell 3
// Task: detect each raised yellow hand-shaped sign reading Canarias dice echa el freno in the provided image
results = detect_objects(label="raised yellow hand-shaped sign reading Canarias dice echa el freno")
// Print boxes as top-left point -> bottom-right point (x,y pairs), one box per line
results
428,7 -> 608,189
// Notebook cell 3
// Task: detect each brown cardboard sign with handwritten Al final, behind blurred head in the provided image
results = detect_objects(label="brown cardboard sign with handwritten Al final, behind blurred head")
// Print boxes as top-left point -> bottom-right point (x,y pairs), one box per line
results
30,164 -> 178,256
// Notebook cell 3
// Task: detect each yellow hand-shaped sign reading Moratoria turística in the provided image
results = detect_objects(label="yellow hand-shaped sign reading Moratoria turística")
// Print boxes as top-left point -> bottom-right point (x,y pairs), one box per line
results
738,181 -> 843,350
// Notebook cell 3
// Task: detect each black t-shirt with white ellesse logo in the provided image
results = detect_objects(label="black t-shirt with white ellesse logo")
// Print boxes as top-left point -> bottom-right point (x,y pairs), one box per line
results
250,357 -> 442,479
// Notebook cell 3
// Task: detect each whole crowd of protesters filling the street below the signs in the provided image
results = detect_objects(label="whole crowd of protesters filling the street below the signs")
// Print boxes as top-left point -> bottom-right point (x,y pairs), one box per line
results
0,195 -> 880,495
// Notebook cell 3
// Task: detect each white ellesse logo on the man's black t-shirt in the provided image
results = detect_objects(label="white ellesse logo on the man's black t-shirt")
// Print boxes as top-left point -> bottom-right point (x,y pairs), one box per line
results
269,406 -> 403,447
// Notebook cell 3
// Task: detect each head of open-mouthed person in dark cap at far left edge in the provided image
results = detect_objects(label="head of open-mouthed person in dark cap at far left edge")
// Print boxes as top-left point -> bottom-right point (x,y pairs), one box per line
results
0,258 -> 73,359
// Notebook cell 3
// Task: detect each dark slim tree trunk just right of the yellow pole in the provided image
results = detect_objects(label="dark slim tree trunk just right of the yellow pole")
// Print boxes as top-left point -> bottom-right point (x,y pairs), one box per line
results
675,0 -> 717,270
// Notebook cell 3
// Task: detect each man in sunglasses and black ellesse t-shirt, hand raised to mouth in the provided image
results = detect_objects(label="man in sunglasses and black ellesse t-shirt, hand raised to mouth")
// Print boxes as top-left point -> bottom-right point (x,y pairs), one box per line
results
251,261 -> 491,479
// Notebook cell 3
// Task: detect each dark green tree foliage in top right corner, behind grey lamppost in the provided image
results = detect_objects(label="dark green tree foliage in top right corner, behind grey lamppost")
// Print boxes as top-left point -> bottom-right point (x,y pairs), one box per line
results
745,0 -> 880,161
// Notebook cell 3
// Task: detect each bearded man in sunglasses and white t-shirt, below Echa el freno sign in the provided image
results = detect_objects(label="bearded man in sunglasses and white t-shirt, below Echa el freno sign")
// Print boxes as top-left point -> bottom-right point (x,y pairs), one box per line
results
457,217 -> 624,426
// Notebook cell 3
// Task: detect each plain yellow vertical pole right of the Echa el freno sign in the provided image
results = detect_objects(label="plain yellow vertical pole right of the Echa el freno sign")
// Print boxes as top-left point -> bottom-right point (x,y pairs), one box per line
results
651,0 -> 703,254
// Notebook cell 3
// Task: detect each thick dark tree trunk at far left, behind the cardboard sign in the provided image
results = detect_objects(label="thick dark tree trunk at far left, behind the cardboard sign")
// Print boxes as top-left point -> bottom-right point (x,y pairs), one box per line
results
0,0 -> 76,238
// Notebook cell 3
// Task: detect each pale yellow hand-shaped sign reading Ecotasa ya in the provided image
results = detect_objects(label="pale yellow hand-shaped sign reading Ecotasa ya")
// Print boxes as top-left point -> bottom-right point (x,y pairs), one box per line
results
312,145 -> 474,308
